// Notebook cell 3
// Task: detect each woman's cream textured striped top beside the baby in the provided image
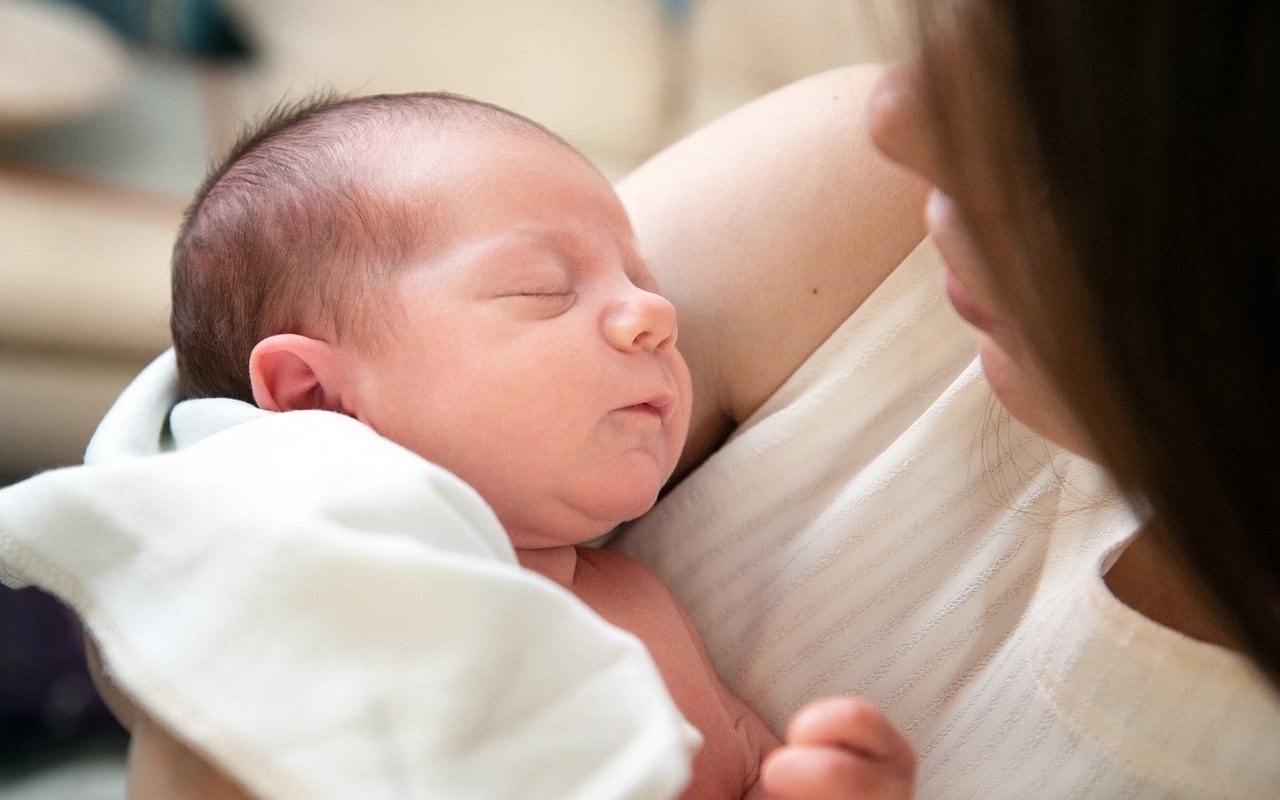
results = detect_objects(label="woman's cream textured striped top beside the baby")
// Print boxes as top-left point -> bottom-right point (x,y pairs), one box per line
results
614,244 -> 1280,799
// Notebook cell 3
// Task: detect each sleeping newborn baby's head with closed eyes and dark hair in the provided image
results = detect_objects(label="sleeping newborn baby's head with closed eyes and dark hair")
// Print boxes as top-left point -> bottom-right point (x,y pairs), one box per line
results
173,95 -> 690,547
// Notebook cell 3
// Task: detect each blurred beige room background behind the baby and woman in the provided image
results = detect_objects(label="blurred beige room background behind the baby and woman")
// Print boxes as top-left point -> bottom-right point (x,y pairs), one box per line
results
0,0 -> 910,800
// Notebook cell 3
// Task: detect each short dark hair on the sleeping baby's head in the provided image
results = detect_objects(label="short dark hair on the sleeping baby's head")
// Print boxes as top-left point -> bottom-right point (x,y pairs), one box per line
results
169,92 -> 568,402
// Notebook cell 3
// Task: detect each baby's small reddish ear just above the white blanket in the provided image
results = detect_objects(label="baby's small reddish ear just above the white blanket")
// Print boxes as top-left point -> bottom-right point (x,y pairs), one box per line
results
248,333 -> 346,412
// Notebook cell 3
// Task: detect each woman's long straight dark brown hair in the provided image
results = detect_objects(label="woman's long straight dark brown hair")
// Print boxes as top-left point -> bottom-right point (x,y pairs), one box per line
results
923,0 -> 1280,685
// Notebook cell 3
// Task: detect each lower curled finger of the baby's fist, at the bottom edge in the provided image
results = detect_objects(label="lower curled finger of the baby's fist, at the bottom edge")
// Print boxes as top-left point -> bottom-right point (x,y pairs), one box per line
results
760,745 -> 914,800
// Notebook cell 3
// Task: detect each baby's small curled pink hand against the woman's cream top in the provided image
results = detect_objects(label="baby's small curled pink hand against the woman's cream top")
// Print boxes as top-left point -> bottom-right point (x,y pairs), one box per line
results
760,698 -> 915,800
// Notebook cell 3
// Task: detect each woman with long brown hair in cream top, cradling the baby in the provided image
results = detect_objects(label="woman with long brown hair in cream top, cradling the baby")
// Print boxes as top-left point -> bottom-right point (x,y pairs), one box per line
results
10,0 -> 1280,797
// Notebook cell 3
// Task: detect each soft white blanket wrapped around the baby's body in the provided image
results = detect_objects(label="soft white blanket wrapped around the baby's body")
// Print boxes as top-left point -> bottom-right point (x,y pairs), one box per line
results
0,355 -> 698,800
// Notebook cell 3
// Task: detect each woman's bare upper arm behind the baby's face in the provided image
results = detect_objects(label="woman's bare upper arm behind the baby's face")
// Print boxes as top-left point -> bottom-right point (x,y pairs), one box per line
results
618,67 -> 925,476
